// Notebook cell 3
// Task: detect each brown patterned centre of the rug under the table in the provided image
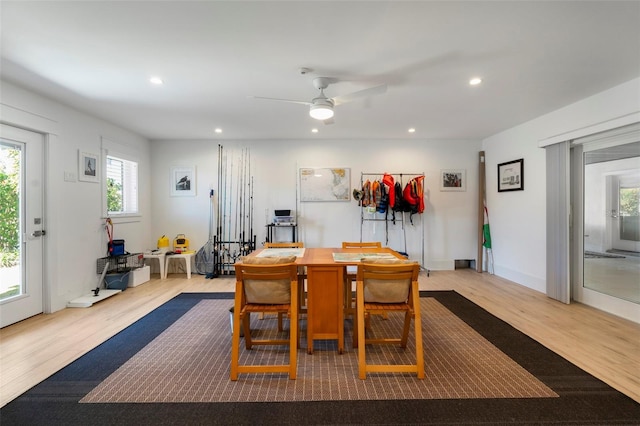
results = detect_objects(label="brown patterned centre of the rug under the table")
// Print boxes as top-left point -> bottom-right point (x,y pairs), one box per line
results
80,297 -> 558,403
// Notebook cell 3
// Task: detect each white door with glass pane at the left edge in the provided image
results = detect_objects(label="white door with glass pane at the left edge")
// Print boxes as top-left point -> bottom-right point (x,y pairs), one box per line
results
0,124 -> 44,327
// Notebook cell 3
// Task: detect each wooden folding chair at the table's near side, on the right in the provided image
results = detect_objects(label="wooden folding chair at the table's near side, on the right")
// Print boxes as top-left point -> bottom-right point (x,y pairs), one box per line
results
353,261 -> 424,379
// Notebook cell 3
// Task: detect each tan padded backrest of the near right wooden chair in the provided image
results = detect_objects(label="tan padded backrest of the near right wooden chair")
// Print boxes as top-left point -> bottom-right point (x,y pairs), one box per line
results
356,260 -> 420,303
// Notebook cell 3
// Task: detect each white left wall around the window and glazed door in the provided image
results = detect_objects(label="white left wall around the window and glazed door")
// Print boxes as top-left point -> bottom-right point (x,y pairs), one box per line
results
0,81 -> 151,312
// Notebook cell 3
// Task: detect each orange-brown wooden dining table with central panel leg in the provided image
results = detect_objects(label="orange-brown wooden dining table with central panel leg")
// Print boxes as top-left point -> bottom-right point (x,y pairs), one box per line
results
244,247 -> 403,354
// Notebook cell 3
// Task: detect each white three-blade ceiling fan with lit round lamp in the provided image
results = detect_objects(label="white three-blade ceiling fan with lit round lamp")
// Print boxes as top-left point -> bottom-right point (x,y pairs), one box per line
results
251,77 -> 387,124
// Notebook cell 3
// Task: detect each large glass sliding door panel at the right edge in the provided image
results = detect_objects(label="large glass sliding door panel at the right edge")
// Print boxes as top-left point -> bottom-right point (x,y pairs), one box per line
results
583,142 -> 640,303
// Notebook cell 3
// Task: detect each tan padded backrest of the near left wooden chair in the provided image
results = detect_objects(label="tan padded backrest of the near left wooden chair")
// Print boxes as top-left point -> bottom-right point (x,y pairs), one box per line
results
235,263 -> 298,305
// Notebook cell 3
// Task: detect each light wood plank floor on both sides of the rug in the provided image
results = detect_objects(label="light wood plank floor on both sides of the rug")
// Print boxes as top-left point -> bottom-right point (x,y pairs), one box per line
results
0,269 -> 640,406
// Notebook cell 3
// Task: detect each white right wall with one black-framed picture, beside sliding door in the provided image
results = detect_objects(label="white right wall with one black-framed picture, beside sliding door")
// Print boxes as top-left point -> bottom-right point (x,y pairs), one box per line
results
483,78 -> 640,300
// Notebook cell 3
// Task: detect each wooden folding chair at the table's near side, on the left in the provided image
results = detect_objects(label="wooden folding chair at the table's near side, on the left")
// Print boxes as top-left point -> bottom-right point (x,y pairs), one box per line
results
230,258 -> 298,380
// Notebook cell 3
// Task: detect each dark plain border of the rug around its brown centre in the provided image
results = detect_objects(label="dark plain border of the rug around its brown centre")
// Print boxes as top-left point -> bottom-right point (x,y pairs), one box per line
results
0,291 -> 640,425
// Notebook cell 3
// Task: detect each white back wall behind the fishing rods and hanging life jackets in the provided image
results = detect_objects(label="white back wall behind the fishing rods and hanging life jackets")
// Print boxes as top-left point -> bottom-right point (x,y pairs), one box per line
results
150,139 -> 480,269
